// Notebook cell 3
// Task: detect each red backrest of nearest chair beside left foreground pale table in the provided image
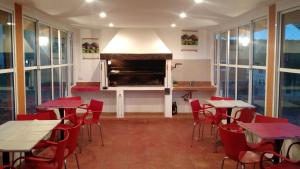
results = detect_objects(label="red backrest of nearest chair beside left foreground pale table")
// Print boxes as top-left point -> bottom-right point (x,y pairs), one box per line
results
52,130 -> 70,169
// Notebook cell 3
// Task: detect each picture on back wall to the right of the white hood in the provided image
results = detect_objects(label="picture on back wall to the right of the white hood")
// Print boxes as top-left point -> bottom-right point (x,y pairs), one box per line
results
181,30 -> 198,52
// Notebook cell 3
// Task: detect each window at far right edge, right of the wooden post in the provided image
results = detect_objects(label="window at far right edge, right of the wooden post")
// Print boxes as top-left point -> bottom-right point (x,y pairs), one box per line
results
278,9 -> 300,125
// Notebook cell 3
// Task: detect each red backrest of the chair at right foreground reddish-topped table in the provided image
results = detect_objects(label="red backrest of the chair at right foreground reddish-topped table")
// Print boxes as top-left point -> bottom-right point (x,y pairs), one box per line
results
219,126 -> 248,161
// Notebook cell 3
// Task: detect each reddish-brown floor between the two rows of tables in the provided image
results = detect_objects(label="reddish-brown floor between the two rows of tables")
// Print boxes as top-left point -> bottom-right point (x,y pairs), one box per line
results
67,116 -> 237,169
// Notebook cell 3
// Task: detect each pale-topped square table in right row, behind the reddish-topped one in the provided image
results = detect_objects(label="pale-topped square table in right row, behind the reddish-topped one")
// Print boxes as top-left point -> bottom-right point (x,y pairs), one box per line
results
206,100 -> 255,124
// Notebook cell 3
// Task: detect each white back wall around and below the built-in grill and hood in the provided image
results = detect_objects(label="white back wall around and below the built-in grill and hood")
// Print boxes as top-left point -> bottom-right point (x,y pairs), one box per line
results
74,28 -> 214,112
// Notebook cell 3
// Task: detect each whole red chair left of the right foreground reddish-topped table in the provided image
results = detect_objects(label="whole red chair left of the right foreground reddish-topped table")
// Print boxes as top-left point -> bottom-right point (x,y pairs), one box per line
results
219,126 -> 260,169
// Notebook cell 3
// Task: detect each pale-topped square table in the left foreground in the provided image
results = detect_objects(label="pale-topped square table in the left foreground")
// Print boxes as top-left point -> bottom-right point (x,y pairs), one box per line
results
0,120 -> 61,164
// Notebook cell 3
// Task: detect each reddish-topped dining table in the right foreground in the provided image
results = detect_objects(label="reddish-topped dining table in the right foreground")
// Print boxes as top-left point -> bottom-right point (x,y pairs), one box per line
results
238,122 -> 300,163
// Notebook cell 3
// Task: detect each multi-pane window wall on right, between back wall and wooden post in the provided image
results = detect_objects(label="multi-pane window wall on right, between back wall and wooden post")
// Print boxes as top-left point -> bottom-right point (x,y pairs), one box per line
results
214,18 -> 268,113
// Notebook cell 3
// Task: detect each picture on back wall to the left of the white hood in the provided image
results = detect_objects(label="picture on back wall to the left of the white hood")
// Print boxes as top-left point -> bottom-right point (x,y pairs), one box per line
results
81,38 -> 100,59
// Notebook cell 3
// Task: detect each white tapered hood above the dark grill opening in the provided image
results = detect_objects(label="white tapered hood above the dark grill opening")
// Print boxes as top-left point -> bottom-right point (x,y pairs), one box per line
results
101,28 -> 171,54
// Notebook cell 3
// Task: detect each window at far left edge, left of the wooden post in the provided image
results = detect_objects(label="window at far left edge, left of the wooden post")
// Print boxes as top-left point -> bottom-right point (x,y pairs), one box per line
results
0,10 -> 15,124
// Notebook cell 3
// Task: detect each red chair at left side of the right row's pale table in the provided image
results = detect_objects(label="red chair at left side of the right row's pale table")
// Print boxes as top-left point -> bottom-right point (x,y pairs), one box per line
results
190,99 -> 211,147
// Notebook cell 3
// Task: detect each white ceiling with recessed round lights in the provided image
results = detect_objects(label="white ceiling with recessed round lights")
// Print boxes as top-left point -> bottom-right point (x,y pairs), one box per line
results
14,0 -> 270,28
